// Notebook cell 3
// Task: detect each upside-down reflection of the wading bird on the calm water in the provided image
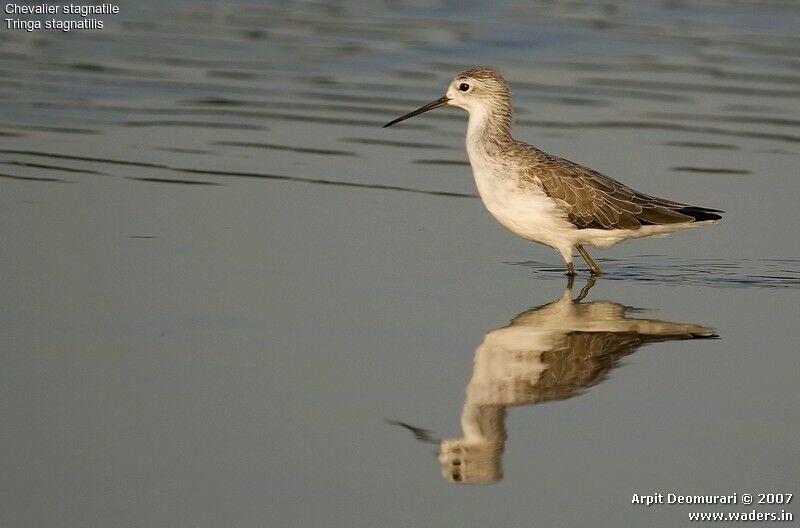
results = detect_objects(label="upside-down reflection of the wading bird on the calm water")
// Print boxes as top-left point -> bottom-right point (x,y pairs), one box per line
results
390,281 -> 717,483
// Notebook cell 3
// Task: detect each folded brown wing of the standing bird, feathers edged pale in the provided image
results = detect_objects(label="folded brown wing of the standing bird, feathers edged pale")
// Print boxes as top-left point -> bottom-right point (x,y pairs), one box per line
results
530,151 -> 700,229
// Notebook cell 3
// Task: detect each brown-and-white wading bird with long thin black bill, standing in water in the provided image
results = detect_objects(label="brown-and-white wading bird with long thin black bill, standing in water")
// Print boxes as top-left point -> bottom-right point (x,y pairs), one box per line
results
384,68 -> 723,276
